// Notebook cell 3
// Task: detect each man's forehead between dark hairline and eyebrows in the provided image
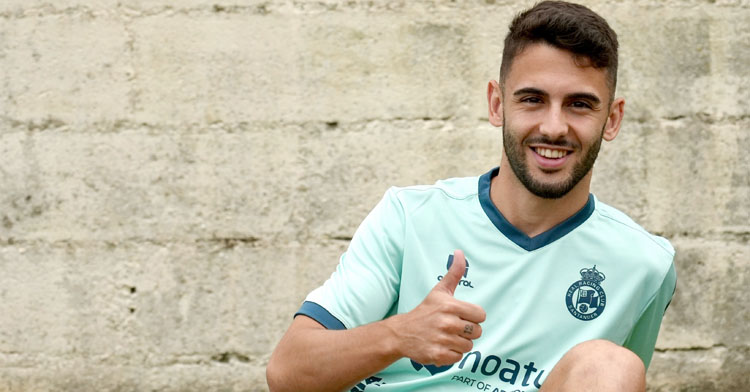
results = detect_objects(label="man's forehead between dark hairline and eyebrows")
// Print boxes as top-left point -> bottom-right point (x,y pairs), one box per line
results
503,43 -> 609,97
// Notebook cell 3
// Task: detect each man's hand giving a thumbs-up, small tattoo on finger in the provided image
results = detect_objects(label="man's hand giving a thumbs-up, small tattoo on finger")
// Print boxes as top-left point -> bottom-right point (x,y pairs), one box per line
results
385,250 -> 486,366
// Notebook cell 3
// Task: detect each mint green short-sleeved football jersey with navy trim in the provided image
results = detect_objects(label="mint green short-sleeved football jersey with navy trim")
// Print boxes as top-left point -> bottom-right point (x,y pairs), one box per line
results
297,168 -> 676,392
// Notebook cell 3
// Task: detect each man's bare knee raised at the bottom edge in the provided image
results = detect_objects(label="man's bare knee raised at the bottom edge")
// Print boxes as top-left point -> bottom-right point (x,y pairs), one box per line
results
542,340 -> 646,391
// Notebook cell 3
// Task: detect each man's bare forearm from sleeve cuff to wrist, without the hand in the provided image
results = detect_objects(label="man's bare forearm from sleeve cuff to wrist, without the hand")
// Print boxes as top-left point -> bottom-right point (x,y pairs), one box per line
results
266,316 -> 402,392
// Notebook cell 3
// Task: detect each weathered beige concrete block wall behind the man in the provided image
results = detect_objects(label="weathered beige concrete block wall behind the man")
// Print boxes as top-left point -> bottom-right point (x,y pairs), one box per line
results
0,0 -> 750,391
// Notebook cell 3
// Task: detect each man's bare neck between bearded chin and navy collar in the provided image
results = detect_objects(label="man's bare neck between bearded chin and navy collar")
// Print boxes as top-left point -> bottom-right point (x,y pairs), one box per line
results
490,156 -> 591,237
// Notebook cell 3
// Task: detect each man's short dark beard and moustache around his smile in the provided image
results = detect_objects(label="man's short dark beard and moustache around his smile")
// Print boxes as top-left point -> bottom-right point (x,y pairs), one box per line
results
503,116 -> 604,199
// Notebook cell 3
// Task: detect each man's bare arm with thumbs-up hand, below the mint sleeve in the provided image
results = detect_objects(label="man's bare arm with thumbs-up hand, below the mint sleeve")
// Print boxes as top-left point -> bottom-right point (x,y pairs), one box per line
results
266,251 -> 485,392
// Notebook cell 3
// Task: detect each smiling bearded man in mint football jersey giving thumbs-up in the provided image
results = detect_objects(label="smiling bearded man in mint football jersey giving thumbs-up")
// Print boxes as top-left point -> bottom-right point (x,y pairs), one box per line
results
267,2 -> 676,392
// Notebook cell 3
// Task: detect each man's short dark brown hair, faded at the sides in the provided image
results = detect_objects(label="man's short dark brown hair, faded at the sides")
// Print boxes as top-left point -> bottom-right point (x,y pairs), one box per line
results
500,1 -> 618,99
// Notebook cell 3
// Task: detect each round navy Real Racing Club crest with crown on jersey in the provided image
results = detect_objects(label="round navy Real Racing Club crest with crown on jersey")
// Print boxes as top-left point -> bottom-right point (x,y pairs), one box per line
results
565,266 -> 607,321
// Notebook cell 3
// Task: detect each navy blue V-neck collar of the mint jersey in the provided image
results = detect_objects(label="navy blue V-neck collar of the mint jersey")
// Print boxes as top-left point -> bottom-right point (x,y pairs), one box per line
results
479,167 -> 594,251
